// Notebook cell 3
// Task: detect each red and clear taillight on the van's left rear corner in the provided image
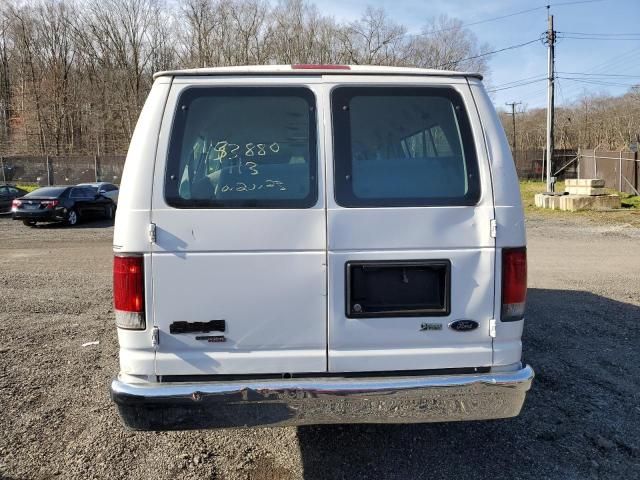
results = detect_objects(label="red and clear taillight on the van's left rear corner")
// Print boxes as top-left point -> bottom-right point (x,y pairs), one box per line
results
113,256 -> 146,330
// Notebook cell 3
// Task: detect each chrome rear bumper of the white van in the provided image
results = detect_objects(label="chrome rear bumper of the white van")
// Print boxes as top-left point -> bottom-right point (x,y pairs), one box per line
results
111,365 -> 534,430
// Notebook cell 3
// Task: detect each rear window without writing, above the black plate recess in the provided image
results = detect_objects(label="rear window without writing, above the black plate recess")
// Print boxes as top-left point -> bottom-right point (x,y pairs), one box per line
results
331,87 -> 480,207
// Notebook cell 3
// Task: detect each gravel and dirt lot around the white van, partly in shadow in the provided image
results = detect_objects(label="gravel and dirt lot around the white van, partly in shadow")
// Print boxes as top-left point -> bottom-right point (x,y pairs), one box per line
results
0,214 -> 640,480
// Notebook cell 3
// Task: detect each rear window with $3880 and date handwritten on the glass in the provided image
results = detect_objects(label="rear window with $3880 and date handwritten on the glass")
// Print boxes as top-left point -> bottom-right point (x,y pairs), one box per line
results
165,87 -> 317,208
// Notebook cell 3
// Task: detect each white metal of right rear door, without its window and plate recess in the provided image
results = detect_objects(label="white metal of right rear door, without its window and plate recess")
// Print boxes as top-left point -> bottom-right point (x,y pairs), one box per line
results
325,75 -> 496,372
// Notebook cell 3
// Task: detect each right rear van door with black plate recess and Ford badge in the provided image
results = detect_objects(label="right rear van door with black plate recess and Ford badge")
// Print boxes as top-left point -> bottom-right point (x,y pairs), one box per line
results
325,81 -> 495,372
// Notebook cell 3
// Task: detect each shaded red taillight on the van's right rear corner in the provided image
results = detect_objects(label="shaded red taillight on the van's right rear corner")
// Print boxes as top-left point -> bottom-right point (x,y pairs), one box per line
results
501,247 -> 527,322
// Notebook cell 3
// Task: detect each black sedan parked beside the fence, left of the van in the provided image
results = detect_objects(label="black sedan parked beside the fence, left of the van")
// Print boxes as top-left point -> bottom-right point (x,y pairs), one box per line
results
11,187 -> 116,226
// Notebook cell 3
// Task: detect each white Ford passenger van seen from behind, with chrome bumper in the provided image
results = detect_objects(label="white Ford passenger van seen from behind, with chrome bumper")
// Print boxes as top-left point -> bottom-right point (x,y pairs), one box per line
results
111,65 -> 534,430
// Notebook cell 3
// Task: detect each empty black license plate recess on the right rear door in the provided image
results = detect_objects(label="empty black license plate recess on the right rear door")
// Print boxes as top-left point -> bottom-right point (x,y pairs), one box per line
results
346,260 -> 451,318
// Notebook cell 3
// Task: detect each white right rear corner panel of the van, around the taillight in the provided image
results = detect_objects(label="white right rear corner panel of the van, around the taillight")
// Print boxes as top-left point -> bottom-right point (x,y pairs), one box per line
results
469,79 -> 526,366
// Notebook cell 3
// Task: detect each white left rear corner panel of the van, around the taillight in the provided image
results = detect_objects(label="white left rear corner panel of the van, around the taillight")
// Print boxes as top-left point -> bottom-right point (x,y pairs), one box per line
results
113,77 -> 171,375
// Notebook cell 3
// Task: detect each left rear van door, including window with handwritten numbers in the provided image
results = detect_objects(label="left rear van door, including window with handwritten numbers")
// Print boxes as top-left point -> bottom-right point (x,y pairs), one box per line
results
151,77 -> 327,376
